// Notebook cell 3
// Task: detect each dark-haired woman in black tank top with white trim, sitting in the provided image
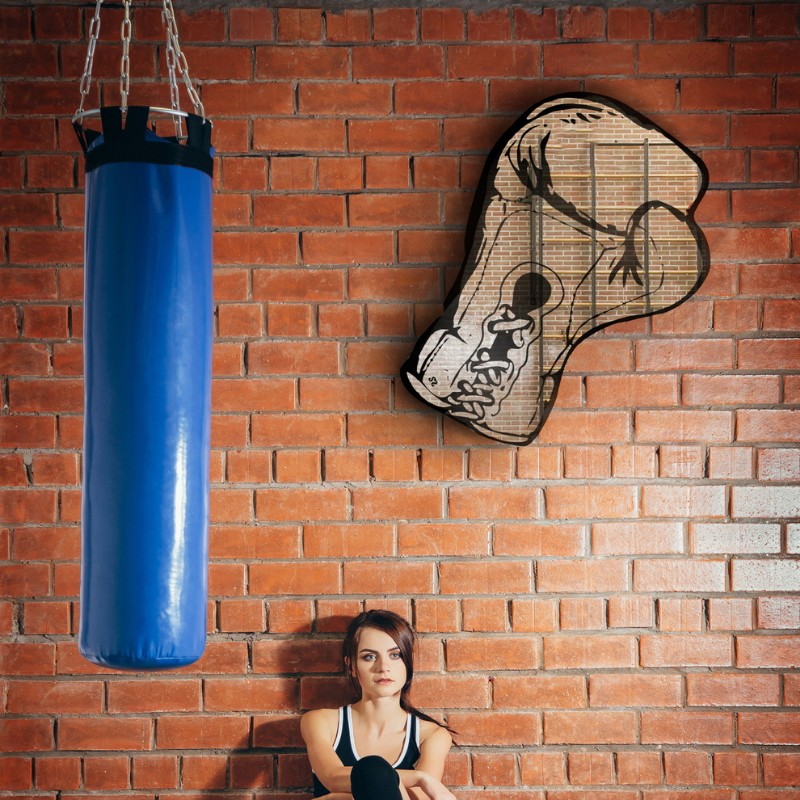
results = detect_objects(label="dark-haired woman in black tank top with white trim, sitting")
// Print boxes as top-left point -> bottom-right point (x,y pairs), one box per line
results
300,610 -> 455,800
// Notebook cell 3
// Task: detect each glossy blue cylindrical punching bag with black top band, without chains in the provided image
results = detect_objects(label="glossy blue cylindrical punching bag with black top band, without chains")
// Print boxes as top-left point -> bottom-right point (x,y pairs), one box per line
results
75,106 -> 213,670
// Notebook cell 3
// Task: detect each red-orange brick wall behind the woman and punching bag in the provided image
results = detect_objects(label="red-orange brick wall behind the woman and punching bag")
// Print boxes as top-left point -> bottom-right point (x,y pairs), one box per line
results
0,2 -> 800,800
